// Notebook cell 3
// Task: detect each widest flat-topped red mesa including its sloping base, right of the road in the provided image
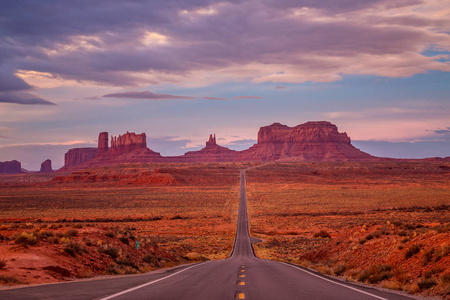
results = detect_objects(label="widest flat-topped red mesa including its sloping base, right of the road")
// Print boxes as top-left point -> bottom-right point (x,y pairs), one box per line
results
240,121 -> 375,161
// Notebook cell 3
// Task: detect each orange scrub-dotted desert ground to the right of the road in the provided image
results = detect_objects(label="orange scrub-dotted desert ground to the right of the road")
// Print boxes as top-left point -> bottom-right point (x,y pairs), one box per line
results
247,162 -> 450,297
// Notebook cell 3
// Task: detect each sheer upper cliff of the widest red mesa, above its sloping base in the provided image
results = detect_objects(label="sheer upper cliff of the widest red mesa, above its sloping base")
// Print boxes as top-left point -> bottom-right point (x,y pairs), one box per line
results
258,121 -> 350,144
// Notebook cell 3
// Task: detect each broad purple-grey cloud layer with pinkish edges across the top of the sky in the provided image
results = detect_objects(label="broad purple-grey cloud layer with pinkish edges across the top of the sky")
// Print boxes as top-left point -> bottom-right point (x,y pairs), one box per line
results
0,0 -> 450,90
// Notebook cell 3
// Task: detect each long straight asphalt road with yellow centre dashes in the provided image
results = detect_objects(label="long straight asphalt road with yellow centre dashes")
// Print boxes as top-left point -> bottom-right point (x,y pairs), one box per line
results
0,172 -> 418,300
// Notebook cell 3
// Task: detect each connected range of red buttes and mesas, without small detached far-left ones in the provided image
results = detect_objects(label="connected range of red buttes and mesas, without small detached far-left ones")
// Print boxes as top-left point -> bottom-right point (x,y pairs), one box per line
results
59,121 -> 379,169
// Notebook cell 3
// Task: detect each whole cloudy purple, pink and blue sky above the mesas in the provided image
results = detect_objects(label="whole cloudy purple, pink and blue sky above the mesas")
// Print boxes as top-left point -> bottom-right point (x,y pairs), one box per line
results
0,0 -> 450,170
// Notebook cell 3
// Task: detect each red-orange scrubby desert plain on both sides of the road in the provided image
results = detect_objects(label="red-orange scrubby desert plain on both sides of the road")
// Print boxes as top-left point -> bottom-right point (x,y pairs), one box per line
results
0,160 -> 450,299
